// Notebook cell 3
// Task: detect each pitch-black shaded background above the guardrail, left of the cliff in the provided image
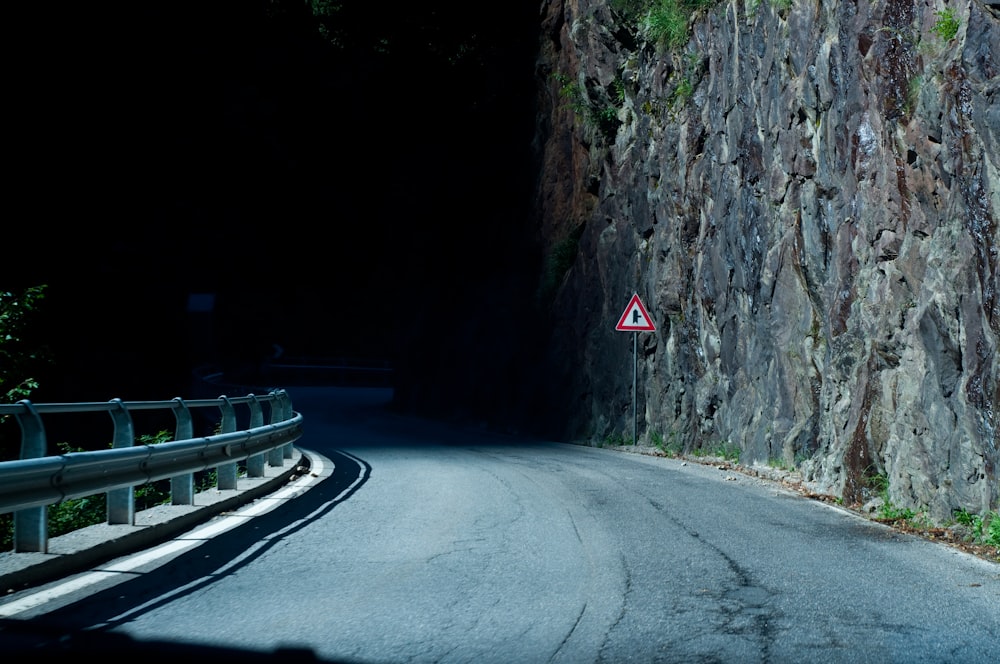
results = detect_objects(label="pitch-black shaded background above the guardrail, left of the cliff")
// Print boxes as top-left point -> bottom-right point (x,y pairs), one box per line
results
2,0 -> 537,420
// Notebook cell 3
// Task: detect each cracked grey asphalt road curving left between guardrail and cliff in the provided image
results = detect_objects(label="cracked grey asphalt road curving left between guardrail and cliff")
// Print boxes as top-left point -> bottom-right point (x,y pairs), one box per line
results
0,389 -> 1000,664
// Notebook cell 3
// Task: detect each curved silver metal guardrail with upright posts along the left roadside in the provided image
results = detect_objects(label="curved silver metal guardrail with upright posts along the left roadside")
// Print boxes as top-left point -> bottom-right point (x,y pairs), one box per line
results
0,390 -> 302,553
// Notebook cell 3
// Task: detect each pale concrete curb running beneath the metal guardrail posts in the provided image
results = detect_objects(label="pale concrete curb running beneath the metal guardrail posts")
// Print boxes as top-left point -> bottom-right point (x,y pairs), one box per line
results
0,448 -> 304,594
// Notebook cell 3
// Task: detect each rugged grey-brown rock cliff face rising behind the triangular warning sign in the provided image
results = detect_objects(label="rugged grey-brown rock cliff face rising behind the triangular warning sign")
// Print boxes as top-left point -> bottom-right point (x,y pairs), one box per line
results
537,0 -> 1000,518
